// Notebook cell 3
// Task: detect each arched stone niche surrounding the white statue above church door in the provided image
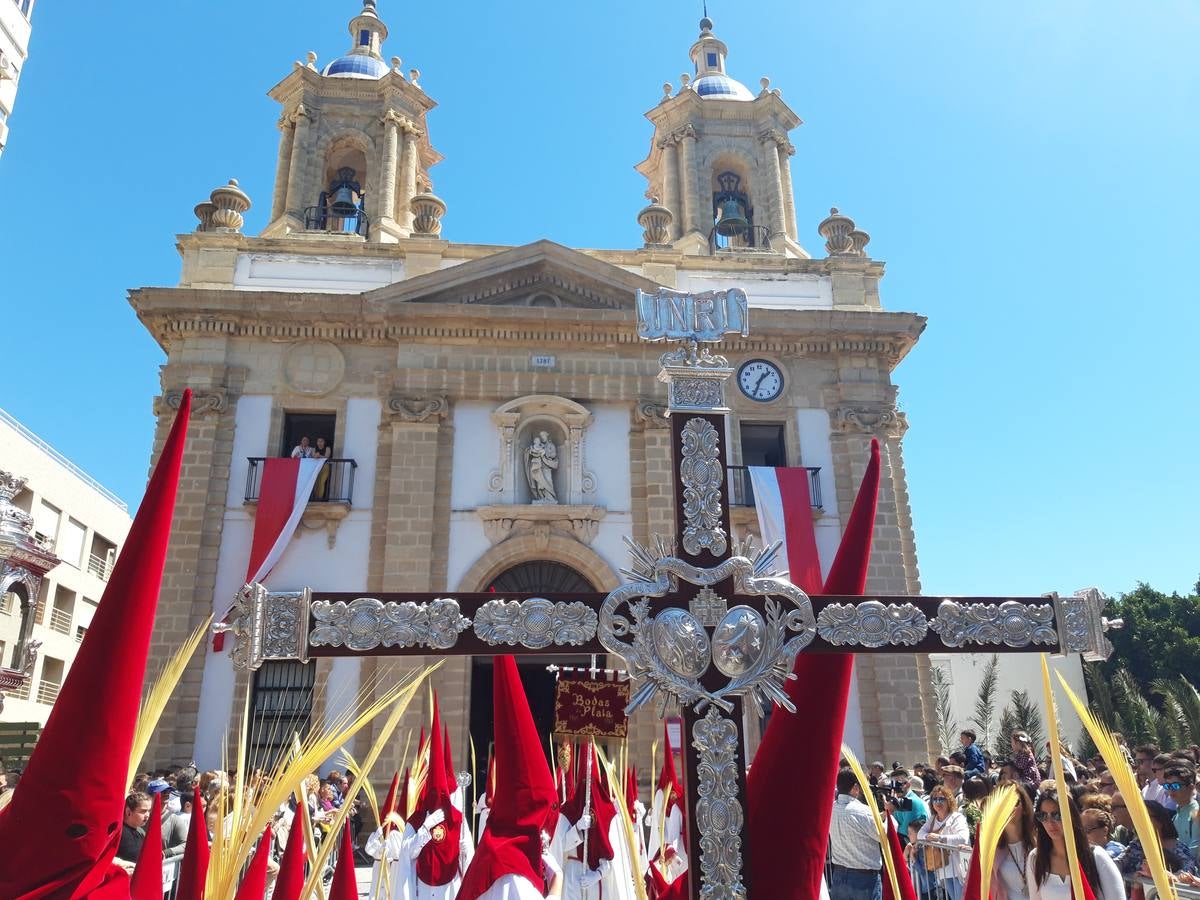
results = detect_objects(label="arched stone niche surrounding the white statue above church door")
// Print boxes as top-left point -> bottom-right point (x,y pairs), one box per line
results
488,394 -> 596,505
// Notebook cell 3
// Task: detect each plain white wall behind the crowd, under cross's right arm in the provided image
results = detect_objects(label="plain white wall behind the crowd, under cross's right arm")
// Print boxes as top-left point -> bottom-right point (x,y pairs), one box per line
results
930,653 -> 1087,756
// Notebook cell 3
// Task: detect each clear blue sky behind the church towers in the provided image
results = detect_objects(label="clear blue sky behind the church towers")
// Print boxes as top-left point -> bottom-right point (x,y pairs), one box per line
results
0,0 -> 1200,602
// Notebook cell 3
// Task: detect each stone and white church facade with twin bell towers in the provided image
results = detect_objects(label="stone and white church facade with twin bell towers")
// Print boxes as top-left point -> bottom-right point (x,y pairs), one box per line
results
131,0 -> 936,782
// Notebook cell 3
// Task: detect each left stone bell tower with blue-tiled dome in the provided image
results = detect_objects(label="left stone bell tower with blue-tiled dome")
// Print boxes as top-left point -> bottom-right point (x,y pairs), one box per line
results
263,0 -> 445,242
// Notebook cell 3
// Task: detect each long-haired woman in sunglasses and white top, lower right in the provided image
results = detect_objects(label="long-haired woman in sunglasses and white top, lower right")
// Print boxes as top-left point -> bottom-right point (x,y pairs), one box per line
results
1025,788 -> 1126,900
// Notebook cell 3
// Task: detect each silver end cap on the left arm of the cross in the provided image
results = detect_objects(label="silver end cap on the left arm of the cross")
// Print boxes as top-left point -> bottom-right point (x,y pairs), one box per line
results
212,583 -> 312,671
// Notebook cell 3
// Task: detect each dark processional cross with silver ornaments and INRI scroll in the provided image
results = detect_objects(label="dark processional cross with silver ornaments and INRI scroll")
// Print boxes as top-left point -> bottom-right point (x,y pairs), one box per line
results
216,288 -> 1111,900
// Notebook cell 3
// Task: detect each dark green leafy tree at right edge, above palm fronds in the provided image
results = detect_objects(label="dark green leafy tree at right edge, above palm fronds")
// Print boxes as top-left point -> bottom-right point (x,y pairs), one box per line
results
1104,583 -> 1200,686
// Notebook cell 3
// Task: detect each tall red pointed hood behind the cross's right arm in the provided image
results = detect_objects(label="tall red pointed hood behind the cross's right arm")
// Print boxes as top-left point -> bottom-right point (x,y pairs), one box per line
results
746,440 -> 880,900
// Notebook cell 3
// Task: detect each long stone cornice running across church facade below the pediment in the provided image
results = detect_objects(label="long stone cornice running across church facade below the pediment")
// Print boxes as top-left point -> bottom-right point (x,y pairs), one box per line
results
130,288 -> 925,366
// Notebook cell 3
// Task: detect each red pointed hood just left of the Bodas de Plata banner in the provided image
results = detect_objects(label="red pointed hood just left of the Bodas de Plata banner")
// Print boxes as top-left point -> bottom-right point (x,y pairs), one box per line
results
457,656 -> 558,900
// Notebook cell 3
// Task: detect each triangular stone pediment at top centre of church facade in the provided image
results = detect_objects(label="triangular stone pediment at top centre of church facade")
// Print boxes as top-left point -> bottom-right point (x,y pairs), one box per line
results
364,240 -> 660,310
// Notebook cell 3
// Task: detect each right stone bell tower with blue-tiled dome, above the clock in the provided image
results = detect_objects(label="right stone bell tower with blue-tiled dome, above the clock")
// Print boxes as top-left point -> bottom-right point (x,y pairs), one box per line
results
636,16 -> 809,258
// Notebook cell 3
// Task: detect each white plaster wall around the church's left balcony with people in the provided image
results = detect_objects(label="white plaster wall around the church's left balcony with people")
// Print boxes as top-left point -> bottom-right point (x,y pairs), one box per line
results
194,396 -> 382,767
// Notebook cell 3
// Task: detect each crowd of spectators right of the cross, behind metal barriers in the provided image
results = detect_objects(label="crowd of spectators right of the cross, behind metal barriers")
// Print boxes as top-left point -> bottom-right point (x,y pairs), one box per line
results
827,730 -> 1200,900
